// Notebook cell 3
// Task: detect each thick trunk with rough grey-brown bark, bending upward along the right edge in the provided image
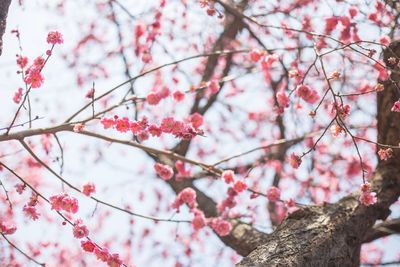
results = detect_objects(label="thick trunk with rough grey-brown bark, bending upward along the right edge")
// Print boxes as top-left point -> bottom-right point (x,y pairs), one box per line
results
238,42 -> 400,267
